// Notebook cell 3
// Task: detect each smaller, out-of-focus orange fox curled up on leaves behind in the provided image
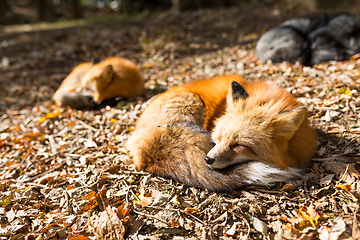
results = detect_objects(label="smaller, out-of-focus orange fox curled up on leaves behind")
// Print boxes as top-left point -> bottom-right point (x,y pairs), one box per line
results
53,57 -> 144,109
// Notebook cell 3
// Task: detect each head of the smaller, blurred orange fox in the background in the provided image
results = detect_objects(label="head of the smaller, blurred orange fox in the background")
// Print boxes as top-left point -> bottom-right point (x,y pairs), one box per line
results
81,65 -> 114,103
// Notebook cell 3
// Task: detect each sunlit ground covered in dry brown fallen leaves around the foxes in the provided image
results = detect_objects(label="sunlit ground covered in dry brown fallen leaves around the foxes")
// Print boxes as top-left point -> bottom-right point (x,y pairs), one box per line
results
0,5 -> 360,240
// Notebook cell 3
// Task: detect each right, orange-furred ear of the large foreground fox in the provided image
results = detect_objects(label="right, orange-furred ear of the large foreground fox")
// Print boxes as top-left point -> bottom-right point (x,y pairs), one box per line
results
274,106 -> 306,140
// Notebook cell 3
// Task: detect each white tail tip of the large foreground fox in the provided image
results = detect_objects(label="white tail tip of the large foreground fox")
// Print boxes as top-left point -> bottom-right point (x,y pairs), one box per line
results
246,162 -> 301,186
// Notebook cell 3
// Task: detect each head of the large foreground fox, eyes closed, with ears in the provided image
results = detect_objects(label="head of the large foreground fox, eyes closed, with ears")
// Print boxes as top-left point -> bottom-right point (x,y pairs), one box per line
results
205,81 -> 306,169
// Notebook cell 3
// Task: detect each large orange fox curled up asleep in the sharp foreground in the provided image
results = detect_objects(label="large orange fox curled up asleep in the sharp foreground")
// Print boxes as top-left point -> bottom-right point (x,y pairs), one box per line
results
125,75 -> 316,191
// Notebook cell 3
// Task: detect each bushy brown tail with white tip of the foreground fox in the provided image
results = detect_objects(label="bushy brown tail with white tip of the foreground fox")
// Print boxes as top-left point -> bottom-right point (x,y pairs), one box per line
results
126,123 -> 298,191
